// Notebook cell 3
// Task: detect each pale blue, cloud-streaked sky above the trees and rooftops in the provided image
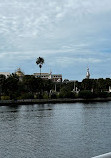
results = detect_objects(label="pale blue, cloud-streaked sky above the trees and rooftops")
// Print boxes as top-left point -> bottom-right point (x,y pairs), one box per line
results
0,0 -> 111,81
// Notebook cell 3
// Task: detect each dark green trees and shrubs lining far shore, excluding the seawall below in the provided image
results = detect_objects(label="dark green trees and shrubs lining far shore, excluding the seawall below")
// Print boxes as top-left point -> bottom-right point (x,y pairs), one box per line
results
0,73 -> 111,100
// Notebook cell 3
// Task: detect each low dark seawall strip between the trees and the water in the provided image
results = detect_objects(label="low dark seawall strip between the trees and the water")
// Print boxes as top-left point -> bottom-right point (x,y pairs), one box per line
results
0,97 -> 111,105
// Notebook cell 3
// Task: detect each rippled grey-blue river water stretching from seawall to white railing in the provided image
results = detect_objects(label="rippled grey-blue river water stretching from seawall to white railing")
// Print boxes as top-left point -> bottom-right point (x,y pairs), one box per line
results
0,102 -> 111,158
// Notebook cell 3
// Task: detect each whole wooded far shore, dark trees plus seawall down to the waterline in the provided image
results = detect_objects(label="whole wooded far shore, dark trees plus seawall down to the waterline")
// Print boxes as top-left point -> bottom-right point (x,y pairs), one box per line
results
0,74 -> 111,104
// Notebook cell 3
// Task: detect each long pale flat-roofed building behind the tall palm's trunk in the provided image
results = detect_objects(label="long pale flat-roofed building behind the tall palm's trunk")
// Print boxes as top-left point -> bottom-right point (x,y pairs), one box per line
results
33,72 -> 62,82
